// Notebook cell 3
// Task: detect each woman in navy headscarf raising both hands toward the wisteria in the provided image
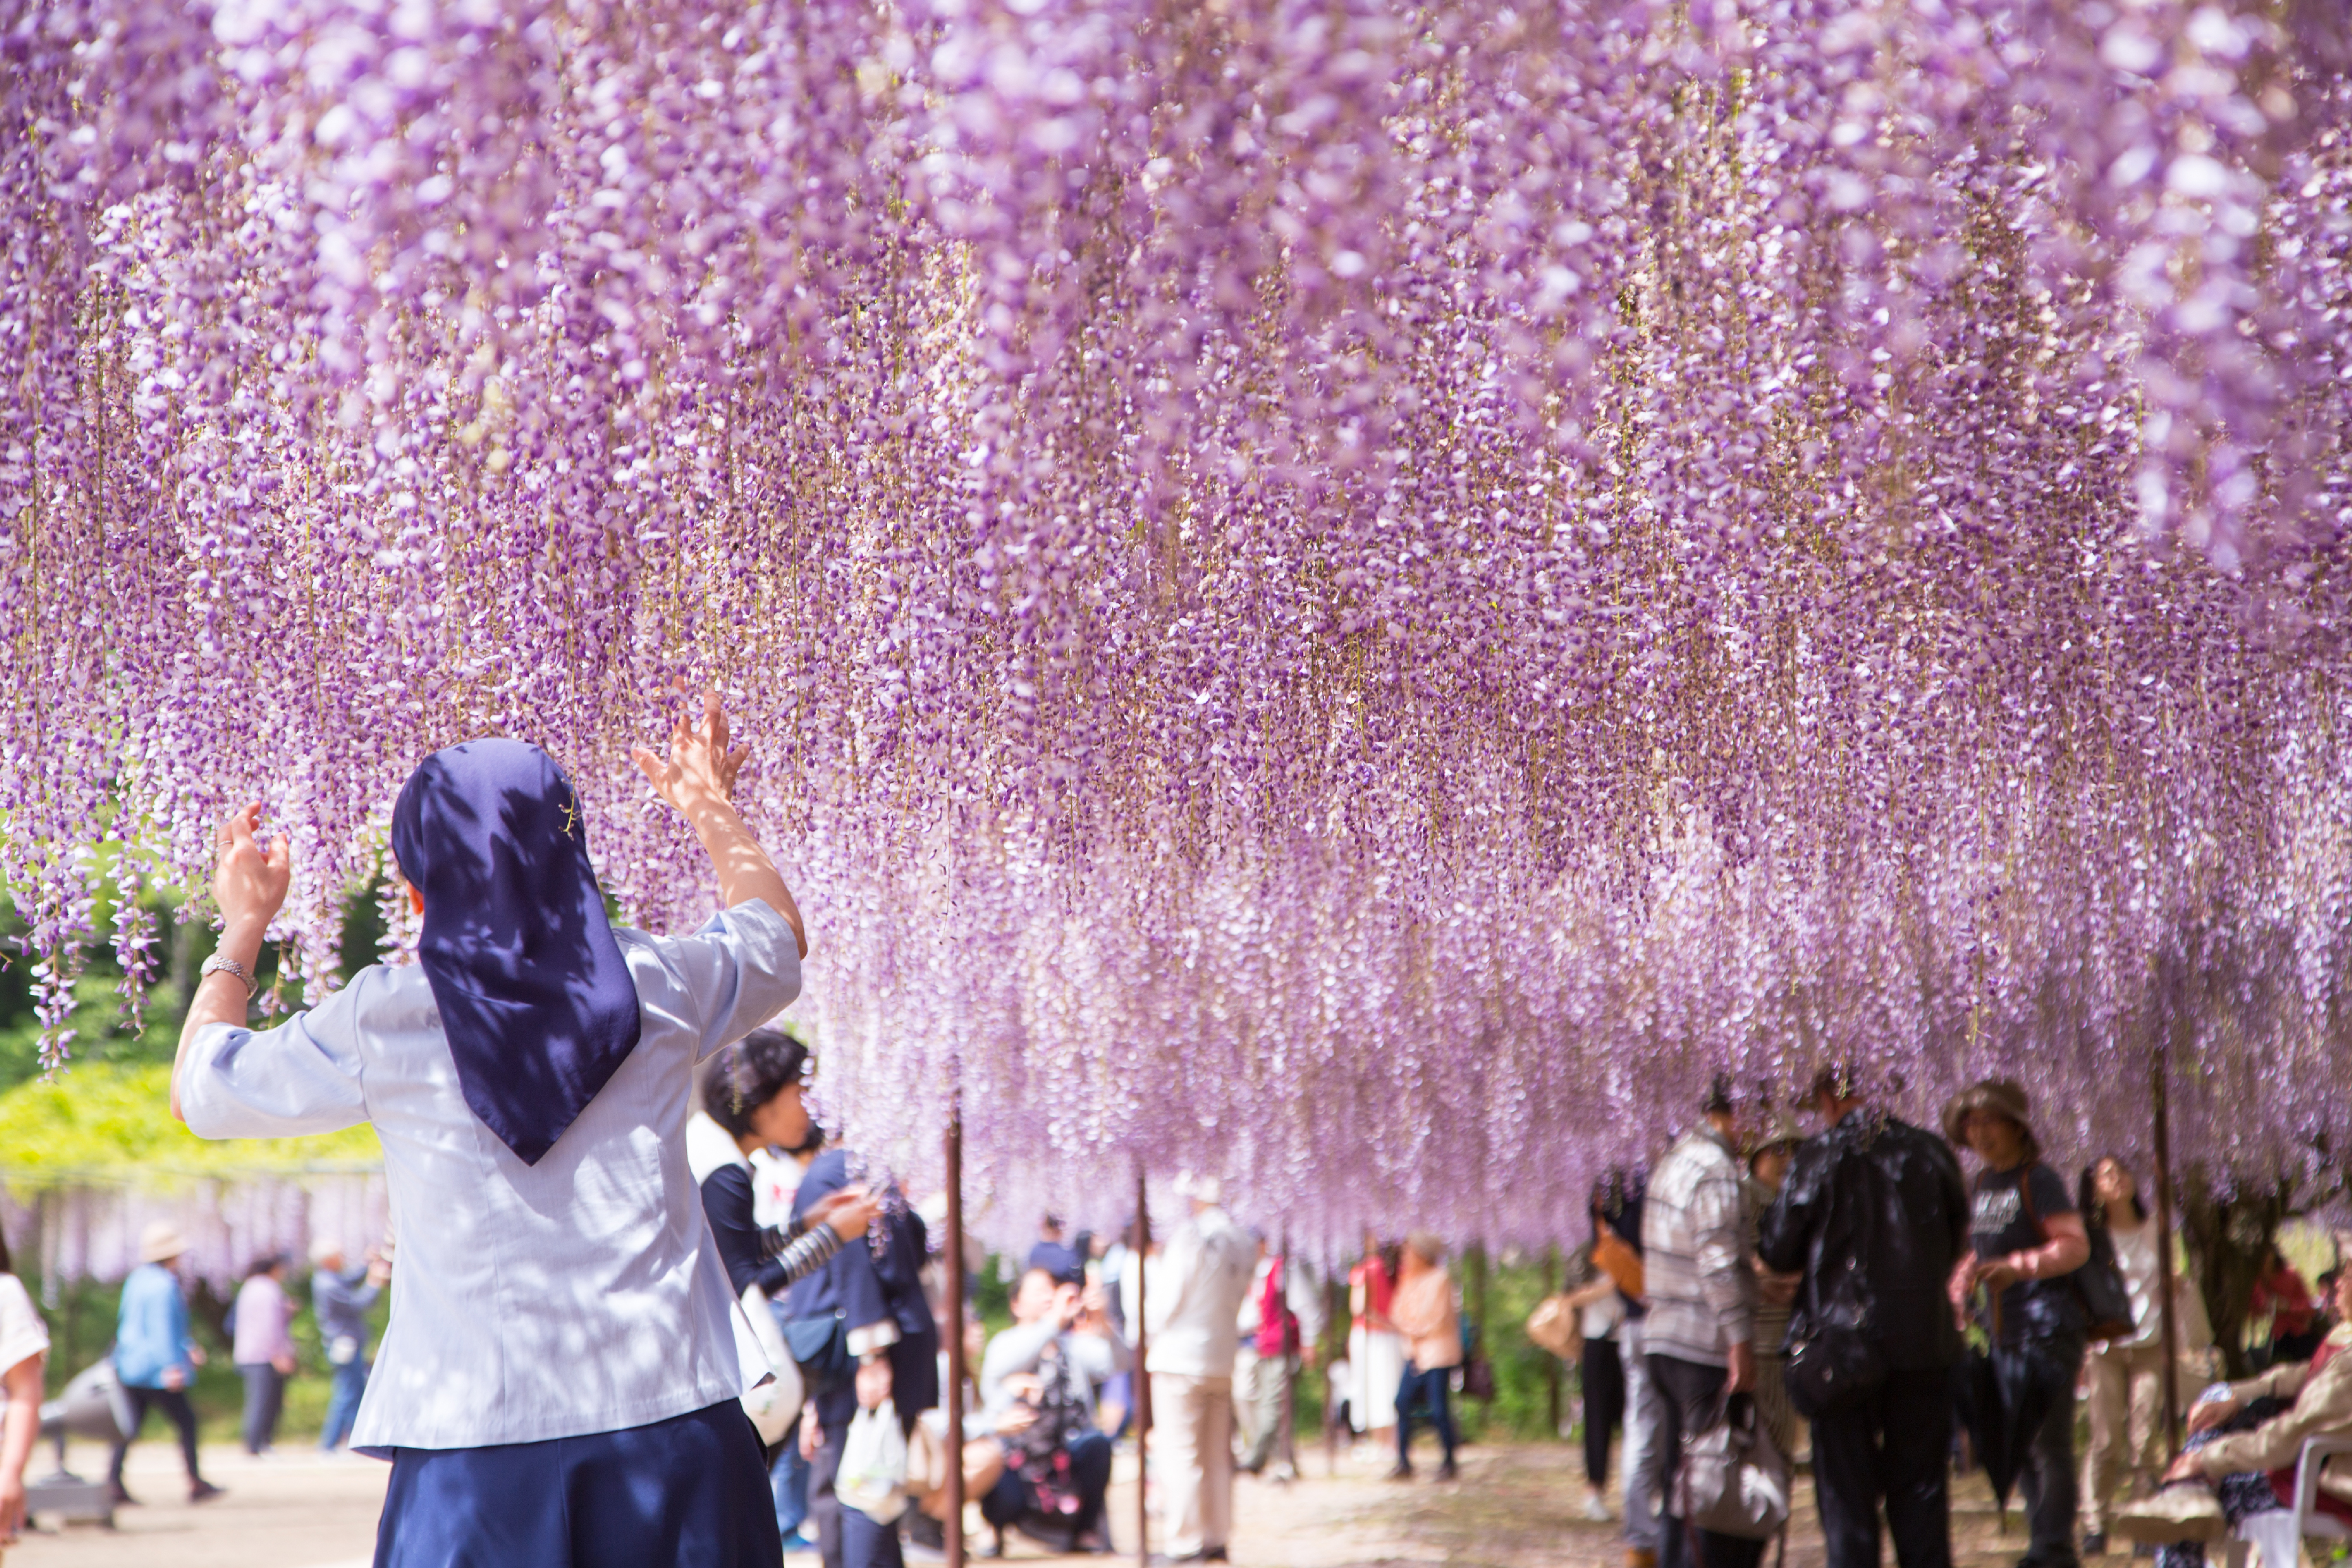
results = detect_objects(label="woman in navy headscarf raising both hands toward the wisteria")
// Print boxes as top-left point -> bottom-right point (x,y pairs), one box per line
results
174,696 -> 805,1568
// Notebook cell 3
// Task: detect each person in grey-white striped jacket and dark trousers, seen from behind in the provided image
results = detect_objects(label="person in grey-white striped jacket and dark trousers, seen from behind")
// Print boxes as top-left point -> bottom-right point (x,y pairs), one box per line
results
1642,1077 -> 1764,1568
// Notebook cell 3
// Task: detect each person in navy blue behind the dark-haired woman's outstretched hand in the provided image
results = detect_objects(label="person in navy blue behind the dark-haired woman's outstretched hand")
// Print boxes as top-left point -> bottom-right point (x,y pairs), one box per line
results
785,1150 -> 939,1568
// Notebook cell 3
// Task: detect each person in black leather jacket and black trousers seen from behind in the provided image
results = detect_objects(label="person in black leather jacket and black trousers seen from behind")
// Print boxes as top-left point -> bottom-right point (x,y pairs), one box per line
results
1757,1067 -> 1969,1568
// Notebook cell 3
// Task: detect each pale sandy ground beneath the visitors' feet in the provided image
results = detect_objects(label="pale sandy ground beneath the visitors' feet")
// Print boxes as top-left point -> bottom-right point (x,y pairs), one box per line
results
7,1441 -> 2079,1568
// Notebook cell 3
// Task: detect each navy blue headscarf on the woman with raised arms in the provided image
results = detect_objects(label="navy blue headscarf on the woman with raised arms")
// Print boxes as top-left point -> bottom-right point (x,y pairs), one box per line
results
393,741 -> 638,1166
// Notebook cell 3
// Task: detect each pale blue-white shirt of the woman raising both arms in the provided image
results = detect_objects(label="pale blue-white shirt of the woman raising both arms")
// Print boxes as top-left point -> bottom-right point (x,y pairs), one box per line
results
179,900 -> 800,1453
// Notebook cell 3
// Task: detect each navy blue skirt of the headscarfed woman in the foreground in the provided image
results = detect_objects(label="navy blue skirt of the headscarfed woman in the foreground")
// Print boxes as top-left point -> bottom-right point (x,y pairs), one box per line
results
376,1399 -> 783,1568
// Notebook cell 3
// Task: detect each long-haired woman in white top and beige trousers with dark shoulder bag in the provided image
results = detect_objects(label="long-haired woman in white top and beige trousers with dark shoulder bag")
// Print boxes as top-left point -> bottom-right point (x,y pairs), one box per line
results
2074,1154 -> 2213,1556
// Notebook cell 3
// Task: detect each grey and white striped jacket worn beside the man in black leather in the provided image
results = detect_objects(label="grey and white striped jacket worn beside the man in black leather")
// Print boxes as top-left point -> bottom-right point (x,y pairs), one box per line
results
1642,1124 -> 1757,1366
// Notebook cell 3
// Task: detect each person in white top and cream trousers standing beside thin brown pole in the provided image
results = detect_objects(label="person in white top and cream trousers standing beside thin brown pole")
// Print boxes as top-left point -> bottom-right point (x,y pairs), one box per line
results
1143,1173 -> 1259,1563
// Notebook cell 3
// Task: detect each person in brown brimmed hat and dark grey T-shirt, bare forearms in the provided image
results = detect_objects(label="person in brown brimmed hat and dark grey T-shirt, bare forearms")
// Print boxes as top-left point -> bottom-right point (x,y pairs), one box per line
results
1943,1079 -> 2091,1568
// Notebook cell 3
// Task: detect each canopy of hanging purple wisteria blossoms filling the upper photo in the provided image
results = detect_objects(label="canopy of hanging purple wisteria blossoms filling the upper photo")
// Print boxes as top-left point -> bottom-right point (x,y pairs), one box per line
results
0,0 -> 2352,1237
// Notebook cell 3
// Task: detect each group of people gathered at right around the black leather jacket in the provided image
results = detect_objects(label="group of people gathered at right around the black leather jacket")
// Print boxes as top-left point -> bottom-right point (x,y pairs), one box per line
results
1555,1069 -> 2352,1568
